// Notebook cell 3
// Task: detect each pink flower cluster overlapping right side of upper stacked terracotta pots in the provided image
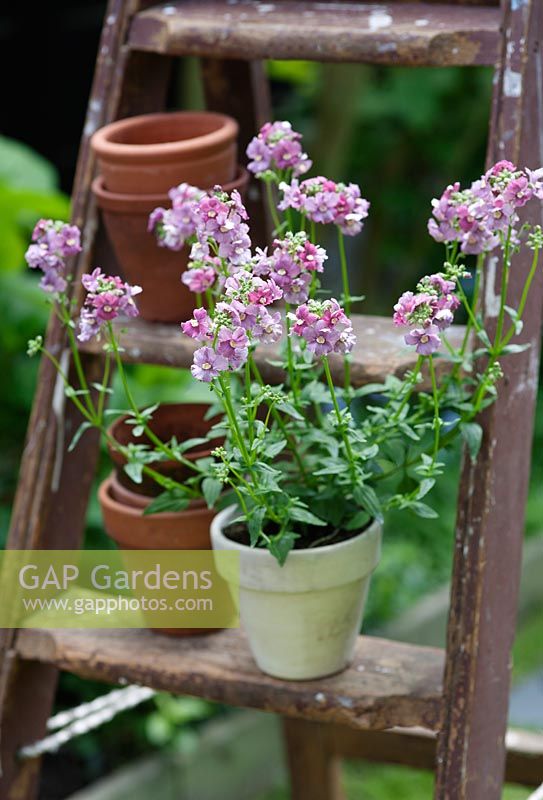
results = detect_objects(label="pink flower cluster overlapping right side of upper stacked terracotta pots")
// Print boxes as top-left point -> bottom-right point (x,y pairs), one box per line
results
147,183 -> 205,250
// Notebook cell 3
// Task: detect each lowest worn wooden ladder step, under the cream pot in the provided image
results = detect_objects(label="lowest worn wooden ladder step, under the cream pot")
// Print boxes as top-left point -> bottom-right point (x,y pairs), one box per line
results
16,629 -> 444,730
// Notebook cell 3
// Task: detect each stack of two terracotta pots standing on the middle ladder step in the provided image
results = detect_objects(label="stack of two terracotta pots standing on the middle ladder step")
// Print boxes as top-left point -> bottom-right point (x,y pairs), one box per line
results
91,111 -> 247,322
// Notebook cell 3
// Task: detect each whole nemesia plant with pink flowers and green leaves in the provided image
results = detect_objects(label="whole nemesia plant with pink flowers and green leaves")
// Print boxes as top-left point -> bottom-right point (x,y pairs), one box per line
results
28,133 -> 543,564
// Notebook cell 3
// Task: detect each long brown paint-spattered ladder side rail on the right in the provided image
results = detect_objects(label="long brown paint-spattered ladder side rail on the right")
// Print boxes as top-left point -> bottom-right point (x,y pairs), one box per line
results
436,0 -> 543,800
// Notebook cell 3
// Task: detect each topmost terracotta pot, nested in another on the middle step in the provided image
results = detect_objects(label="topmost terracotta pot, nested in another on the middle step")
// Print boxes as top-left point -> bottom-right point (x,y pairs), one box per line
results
91,111 -> 239,194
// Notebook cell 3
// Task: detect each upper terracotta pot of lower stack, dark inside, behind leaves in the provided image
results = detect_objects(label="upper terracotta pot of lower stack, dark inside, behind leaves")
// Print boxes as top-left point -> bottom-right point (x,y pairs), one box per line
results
108,403 -> 222,496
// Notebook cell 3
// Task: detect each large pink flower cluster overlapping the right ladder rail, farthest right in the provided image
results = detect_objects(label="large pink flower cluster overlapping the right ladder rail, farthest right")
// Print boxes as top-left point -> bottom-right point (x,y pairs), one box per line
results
428,161 -> 543,254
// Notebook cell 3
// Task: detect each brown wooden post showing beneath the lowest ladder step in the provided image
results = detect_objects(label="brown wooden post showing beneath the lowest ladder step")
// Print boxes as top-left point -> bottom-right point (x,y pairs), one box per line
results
283,717 -> 345,800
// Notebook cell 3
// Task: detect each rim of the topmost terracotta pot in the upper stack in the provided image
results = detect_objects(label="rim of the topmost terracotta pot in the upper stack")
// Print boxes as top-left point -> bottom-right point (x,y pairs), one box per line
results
91,111 -> 239,163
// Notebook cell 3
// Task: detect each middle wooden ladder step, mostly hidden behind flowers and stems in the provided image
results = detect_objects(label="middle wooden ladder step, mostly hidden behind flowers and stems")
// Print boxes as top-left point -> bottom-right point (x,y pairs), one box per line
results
81,314 -> 464,386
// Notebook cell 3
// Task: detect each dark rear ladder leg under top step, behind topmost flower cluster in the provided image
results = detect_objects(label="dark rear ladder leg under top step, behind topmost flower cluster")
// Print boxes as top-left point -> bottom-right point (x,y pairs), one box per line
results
202,58 -> 273,247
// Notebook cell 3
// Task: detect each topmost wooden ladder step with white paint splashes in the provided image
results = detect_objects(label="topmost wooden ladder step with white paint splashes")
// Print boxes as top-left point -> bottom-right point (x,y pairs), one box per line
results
128,0 -> 501,66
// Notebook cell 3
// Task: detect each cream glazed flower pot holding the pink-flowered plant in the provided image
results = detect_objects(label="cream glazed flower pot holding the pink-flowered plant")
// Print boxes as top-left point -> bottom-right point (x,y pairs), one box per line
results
211,507 -> 382,680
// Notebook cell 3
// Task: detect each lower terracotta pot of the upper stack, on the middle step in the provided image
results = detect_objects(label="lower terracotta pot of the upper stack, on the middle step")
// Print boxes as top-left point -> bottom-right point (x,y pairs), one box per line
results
92,168 -> 249,322
